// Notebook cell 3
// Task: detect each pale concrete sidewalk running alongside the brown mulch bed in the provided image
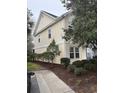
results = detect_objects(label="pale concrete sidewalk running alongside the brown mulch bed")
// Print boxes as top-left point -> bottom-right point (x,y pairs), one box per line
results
35,70 -> 75,93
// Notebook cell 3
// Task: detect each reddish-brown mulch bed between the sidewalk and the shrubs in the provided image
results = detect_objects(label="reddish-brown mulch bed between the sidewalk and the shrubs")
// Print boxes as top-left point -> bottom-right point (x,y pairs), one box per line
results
35,62 -> 97,93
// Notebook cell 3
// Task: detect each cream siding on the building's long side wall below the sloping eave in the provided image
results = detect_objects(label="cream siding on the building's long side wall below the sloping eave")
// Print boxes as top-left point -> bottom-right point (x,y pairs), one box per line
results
34,19 -> 65,63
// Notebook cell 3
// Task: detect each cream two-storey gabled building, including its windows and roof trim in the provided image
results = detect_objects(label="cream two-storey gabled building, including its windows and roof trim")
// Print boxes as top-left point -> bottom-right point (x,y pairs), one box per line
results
34,11 -> 86,64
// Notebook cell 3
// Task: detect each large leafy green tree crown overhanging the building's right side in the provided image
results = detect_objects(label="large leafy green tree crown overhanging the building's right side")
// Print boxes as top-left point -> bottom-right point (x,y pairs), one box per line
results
62,0 -> 97,48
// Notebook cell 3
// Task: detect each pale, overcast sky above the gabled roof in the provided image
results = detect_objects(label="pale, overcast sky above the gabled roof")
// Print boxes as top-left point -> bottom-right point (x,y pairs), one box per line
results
27,0 -> 67,21
